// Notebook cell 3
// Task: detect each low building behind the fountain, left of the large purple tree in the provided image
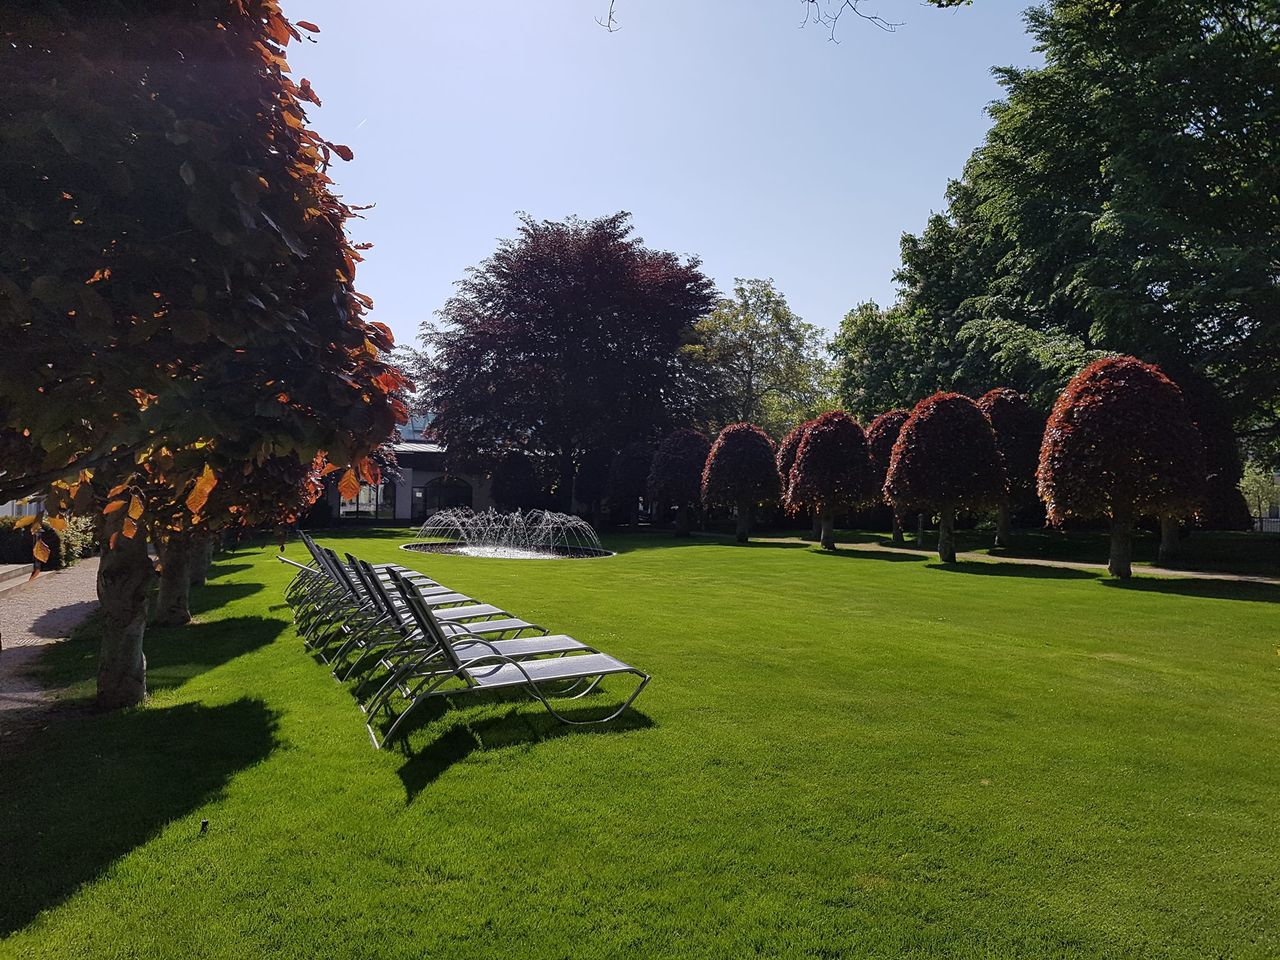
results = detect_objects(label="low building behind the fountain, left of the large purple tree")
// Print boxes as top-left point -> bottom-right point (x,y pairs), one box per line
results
325,416 -> 492,524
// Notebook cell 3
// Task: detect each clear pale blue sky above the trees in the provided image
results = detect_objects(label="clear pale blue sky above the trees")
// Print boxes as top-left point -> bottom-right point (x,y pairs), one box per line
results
284,0 -> 1038,343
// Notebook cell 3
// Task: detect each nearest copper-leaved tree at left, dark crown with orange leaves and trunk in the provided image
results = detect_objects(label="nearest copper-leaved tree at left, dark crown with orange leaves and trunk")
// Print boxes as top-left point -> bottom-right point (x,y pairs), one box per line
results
0,0 -> 403,707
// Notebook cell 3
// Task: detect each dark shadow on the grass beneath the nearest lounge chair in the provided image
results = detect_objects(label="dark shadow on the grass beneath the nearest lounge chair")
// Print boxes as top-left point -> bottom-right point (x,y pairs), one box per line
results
397,696 -> 654,804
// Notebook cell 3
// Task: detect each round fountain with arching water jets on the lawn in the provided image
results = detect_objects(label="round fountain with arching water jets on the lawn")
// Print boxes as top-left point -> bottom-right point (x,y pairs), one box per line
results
404,507 -> 613,559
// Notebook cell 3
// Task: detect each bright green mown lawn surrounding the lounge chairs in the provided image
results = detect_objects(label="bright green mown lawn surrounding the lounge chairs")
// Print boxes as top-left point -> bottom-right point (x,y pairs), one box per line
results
0,531 -> 1280,960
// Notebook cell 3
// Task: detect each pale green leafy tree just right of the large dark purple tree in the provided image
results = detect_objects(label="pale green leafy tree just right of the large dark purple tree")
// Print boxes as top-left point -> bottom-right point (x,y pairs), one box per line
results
685,279 -> 835,438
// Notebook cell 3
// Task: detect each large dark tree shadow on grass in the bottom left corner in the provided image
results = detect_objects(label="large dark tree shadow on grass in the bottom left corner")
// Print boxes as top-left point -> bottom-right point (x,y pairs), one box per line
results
0,699 -> 276,940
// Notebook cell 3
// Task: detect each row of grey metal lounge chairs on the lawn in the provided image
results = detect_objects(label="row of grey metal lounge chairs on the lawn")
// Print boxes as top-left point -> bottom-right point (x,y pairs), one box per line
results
279,532 -> 649,748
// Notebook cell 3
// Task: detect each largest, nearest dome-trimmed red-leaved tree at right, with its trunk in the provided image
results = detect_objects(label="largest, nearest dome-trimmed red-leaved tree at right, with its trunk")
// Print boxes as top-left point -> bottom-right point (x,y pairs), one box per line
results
1037,357 -> 1204,577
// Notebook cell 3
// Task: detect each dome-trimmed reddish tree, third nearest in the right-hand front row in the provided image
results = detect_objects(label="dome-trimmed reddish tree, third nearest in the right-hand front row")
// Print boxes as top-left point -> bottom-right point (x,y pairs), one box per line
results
786,410 -> 878,550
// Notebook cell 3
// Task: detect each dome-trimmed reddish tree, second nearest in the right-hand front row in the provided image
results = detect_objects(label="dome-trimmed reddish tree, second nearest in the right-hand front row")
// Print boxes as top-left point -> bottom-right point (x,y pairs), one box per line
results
884,393 -> 1006,563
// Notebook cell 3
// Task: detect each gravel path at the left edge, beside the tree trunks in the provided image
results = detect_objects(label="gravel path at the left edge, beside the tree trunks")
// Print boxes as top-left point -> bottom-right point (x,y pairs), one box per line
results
0,557 -> 97,746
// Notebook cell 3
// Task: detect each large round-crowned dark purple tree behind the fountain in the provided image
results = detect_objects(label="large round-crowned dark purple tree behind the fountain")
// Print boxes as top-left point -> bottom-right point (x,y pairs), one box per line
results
413,212 -> 713,506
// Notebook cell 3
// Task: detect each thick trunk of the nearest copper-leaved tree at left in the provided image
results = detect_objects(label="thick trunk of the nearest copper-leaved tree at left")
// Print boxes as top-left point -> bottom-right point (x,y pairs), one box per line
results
97,525 -> 155,710
